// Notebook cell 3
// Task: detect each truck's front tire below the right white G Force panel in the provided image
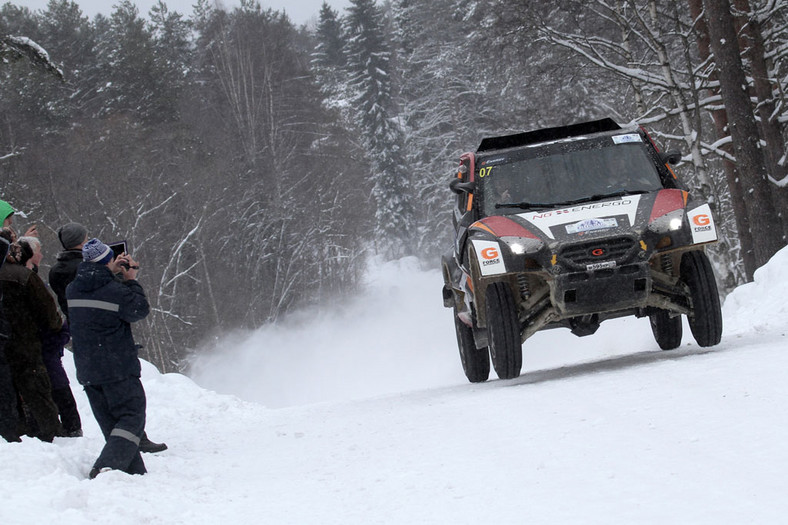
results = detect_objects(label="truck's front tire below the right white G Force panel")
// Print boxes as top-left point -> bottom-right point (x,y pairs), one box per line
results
681,251 -> 722,347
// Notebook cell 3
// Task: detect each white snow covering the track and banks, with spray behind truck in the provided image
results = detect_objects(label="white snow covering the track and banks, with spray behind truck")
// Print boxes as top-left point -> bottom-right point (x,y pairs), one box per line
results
0,248 -> 788,525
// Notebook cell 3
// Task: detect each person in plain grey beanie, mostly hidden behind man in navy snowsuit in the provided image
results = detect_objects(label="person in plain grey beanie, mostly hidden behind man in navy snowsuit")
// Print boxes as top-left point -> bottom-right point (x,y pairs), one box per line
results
49,222 -> 167,453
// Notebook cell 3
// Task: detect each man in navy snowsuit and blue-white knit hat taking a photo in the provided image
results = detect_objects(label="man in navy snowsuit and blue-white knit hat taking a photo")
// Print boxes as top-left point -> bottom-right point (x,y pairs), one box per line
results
66,239 -> 150,479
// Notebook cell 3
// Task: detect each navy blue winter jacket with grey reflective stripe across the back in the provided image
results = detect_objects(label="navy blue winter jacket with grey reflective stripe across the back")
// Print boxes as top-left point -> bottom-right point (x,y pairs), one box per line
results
66,262 -> 150,385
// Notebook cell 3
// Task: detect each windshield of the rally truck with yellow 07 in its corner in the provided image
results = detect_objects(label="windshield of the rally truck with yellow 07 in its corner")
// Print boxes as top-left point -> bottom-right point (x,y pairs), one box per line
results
479,143 -> 662,215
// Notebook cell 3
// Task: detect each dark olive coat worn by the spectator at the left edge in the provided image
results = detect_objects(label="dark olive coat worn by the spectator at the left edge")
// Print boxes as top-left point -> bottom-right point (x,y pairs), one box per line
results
0,263 -> 62,370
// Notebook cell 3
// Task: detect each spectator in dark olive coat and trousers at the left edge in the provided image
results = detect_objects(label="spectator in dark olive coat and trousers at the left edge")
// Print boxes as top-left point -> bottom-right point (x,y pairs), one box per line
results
0,228 -> 62,441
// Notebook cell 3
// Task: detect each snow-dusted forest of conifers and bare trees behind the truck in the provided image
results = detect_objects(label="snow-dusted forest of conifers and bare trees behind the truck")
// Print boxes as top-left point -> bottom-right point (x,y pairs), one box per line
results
0,0 -> 788,372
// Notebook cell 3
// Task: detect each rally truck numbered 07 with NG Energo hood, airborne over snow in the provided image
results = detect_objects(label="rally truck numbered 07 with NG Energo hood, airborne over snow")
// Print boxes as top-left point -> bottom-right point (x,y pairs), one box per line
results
441,119 -> 722,382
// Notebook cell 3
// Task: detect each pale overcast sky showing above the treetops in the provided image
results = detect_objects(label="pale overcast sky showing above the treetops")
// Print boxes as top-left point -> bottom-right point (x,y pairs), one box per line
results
12,0 -> 350,25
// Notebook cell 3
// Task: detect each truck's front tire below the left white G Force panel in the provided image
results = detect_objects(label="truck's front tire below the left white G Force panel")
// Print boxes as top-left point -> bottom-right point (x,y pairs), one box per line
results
485,282 -> 523,379
